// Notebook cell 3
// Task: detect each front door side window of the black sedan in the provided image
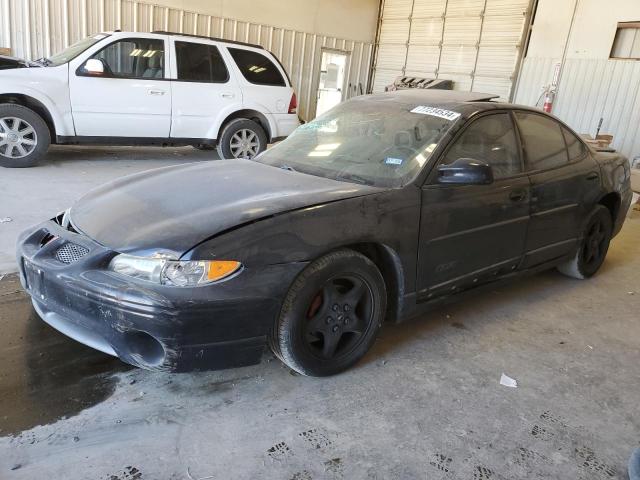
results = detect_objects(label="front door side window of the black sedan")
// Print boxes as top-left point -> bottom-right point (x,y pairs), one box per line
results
442,113 -> 522,179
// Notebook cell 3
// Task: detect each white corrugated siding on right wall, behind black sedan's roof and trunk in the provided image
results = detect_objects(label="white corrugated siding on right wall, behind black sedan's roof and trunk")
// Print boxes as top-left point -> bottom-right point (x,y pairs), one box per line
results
516,58 -> 640,159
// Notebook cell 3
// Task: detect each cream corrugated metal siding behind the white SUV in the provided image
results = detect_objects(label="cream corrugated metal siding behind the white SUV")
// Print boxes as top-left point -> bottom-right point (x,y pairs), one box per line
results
0,0 -> 376,120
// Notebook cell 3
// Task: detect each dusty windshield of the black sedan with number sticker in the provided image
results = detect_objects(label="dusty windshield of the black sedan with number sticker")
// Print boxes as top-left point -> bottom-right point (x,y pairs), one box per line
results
255,97 -> 460,188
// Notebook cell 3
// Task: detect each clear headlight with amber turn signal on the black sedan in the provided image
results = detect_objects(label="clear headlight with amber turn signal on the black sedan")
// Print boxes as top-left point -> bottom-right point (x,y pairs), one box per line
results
109,254 -> 242,287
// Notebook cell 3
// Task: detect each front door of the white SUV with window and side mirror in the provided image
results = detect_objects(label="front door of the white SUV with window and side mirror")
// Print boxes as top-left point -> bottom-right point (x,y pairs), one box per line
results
69,37 -> 171,138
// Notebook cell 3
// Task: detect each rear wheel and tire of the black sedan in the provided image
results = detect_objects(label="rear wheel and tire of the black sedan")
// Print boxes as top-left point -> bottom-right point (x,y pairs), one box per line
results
557,205 -> 613,280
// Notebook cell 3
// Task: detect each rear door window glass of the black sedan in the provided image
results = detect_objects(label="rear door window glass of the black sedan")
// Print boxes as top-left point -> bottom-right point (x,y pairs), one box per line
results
516,112 -> 569,170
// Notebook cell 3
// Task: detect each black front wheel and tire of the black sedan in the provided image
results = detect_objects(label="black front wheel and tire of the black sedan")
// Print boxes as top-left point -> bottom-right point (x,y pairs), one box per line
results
269,249 -> 387,377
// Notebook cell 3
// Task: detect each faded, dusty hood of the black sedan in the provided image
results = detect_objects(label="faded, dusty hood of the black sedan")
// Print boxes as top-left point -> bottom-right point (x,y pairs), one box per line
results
70,160 -> 381,256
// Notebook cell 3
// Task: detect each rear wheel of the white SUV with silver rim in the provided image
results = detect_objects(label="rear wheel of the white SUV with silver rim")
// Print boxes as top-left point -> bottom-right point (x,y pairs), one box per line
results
218,118 -> 267,159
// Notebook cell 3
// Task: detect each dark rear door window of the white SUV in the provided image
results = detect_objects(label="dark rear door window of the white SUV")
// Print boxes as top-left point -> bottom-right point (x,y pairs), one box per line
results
175,42 -> 229,83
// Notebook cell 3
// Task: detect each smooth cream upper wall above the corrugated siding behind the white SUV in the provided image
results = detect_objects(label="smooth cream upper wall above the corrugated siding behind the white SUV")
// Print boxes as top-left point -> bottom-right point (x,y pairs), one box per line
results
153,0 -> 380,42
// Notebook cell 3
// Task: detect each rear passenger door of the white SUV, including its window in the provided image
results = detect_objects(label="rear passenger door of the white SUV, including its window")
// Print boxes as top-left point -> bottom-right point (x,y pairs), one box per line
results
171,40 -> 242,140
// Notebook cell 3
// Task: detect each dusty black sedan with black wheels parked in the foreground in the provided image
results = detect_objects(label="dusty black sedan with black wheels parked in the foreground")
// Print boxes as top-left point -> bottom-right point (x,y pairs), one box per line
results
17,91 -> 631,376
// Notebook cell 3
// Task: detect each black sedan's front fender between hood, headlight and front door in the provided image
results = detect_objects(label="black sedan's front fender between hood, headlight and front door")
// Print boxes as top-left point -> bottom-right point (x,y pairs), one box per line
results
182,188 -> 420,292
